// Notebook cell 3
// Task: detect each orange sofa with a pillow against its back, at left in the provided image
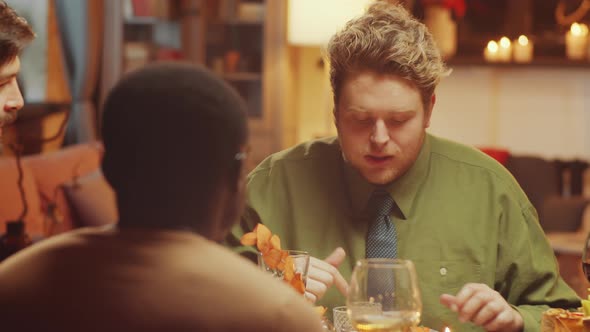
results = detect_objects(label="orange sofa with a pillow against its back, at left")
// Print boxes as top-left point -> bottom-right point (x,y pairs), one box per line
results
0,142 -> 117,239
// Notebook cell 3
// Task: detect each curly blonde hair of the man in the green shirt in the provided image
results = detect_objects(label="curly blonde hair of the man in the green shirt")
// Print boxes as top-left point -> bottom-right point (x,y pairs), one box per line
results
328,1 -> 450,107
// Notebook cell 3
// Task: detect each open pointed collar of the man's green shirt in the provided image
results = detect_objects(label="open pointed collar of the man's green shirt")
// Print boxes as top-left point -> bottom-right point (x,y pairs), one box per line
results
344,134 -> 430,220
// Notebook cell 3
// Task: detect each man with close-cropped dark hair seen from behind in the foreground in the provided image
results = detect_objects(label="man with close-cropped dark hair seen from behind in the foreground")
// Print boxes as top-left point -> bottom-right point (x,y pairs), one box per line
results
0,64 -> 321,332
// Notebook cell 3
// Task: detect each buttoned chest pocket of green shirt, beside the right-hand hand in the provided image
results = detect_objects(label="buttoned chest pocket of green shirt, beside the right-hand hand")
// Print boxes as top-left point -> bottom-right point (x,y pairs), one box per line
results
413,260 -> 482,331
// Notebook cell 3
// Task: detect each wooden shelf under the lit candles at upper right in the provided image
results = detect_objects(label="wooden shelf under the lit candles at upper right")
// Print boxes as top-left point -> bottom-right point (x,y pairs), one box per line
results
447,56 -> 590,69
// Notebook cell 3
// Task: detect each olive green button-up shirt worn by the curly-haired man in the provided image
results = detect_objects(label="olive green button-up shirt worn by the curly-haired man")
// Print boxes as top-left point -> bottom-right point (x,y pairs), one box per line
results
228,135 -> 579,331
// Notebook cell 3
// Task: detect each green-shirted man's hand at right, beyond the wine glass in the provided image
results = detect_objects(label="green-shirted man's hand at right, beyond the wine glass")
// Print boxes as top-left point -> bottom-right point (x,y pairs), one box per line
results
440,284 -> 524,332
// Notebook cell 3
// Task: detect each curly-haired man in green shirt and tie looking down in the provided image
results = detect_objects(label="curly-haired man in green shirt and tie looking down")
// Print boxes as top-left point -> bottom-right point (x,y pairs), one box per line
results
230,2 -> 579,331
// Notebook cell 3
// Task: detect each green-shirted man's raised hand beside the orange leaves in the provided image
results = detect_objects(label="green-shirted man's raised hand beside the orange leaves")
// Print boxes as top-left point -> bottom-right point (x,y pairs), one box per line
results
305,248 -> 348,303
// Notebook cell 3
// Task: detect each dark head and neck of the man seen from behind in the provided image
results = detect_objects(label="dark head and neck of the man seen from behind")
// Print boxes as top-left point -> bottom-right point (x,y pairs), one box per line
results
102,63 -> 248,231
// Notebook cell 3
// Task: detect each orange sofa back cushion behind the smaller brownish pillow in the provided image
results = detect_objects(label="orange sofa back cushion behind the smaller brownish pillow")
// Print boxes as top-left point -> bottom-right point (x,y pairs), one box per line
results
25,142 -> 103,235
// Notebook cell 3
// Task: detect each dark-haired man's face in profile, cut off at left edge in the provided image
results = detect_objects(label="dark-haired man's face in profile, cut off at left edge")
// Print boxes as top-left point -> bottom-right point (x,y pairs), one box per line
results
0,1 -> 35,138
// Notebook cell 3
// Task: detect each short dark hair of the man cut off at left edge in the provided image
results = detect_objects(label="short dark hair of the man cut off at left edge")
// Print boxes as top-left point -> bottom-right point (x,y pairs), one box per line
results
0,0 -> 35,66
